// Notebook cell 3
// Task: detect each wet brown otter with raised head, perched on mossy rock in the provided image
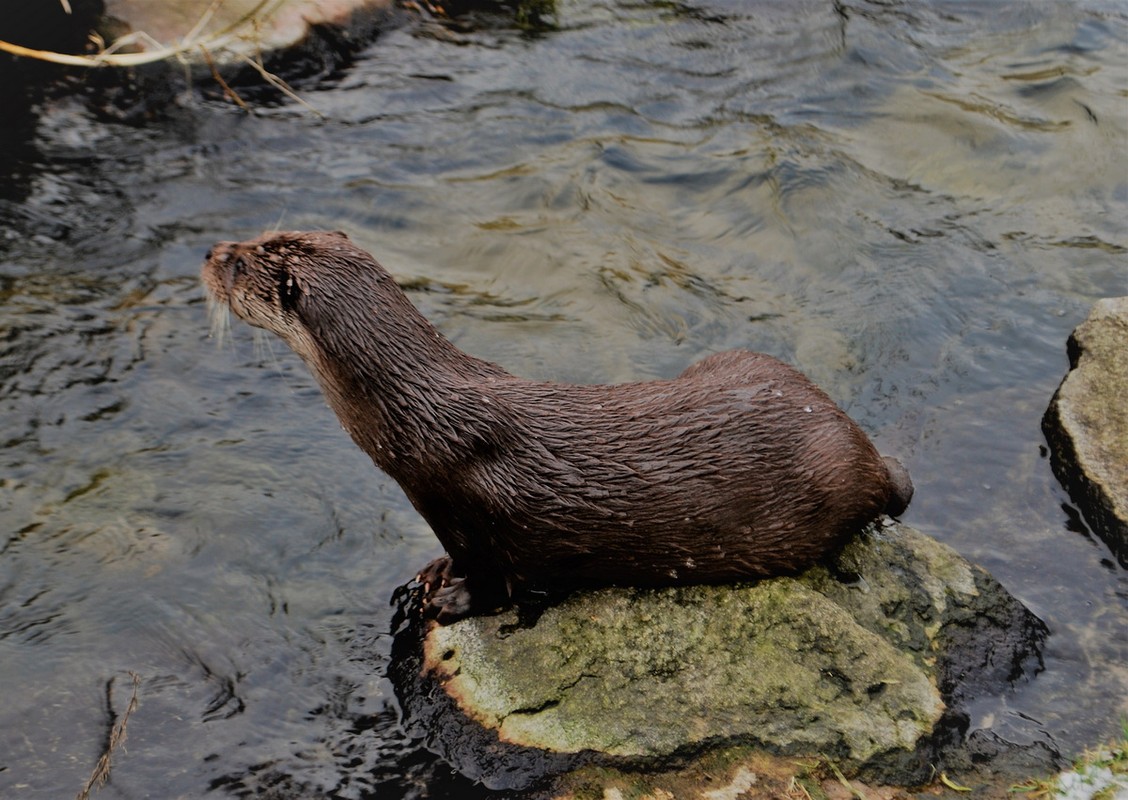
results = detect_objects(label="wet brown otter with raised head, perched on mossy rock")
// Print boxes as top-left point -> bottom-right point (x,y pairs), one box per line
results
202,231 -> 913,624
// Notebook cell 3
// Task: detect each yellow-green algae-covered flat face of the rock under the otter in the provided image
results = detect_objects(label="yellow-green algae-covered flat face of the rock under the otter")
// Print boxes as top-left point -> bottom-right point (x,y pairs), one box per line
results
424,579 -> 944,764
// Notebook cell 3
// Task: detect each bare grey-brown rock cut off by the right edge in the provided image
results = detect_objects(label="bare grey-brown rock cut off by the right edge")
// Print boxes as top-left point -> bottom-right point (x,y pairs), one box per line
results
1042,297 -> 1128,566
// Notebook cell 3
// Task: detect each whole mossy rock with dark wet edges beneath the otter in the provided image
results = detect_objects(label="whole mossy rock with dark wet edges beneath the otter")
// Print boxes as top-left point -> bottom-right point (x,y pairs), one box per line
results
393,525 -> 1046,789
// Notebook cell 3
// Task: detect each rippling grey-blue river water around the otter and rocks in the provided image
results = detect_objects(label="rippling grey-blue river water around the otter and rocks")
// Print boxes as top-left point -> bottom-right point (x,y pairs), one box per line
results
0,0 -> 1128,799
